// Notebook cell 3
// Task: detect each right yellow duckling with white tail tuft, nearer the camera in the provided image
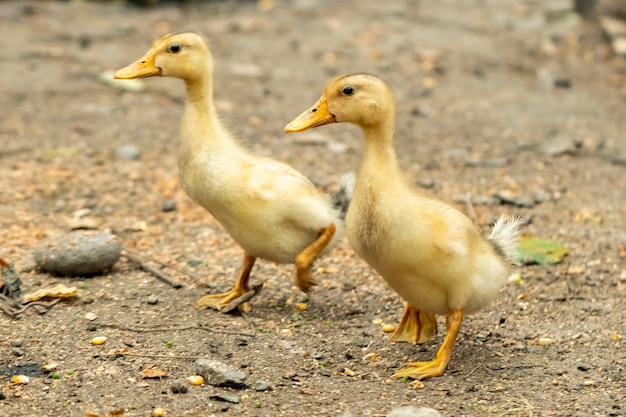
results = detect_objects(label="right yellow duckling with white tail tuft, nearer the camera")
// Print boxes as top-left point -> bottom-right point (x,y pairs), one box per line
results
285,73 -> 520,380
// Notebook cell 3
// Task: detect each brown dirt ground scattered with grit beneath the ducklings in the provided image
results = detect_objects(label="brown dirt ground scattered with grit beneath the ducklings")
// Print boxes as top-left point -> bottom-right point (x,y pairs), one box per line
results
0,0 -> 626,416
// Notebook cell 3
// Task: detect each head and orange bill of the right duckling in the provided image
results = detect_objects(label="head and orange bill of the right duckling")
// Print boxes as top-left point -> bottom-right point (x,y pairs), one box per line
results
285,73 -> 395,132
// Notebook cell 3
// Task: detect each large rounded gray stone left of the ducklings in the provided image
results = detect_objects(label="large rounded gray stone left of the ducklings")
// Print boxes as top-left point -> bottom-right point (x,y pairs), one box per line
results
34,230 -> 122,276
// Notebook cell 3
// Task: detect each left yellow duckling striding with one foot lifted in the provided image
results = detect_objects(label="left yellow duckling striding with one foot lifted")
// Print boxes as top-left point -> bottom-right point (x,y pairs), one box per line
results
114,32 -> 353,311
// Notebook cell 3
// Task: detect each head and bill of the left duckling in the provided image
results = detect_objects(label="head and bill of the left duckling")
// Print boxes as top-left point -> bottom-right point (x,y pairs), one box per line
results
113,32 -> 213,81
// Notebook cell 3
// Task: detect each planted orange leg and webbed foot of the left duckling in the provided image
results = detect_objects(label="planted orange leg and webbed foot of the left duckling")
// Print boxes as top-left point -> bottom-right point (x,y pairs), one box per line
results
196,253 -> 255,313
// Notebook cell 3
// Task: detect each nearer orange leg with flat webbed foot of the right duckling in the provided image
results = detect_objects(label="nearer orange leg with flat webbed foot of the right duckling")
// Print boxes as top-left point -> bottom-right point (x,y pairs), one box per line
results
394,310 -> 463,379
